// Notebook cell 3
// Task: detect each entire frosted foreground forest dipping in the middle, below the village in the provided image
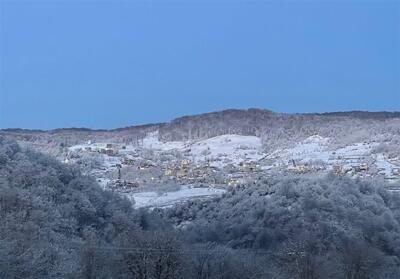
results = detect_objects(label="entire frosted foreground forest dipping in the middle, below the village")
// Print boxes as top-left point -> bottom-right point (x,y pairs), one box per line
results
0,137 -> 400,279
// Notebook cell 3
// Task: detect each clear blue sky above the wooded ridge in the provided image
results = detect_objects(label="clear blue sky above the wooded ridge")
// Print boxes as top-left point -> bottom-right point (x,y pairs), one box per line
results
0,0 -> 400,129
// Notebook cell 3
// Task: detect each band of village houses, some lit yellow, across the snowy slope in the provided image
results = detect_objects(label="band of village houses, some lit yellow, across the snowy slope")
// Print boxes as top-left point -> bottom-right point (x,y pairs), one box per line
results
64,142 -> 400,195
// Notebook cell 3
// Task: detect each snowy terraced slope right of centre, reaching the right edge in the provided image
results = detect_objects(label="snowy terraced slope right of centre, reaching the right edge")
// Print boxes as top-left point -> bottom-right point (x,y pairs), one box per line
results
265,135 -> 400,179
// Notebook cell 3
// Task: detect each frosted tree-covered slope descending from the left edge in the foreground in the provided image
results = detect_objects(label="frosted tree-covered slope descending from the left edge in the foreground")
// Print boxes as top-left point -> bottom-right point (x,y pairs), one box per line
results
0,137 -> 173,278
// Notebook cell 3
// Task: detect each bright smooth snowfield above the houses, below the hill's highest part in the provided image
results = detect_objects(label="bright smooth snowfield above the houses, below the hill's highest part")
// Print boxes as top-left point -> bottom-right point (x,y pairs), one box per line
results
188,135 -> 263,167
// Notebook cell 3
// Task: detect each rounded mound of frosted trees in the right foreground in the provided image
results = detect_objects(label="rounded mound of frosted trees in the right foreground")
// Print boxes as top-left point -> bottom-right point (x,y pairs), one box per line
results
165,175 -> 400,278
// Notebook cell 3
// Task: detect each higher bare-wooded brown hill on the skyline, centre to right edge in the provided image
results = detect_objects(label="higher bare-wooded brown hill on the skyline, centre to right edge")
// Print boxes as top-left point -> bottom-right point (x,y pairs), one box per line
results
159,109 -> 400,148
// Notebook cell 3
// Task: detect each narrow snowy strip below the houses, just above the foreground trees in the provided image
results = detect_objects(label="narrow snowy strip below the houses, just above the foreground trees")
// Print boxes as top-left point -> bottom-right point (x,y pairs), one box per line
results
128,186 -> 226,208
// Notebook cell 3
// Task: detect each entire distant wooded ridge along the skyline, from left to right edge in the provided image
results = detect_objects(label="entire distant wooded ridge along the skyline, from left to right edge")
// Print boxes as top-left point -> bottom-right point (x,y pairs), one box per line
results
0,108 -> 400,151
